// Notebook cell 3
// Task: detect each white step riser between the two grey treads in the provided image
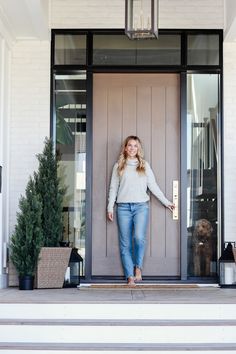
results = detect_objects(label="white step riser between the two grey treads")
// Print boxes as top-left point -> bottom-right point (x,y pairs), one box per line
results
0,322 -> 236,342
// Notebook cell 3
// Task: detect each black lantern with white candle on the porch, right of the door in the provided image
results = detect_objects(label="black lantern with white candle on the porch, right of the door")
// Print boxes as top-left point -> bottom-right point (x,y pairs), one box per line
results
219,242 -> 236,288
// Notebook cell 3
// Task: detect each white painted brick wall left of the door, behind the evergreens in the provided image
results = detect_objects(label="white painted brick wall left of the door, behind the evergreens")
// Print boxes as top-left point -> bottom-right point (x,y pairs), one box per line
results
10,40 -> 50,233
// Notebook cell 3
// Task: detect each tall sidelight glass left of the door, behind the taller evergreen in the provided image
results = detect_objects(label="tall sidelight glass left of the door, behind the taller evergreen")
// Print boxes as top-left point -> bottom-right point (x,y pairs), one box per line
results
55,71 -> 87,272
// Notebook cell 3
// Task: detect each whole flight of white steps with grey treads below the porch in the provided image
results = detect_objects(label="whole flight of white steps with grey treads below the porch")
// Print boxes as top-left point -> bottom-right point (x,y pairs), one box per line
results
0,303 -> 236,354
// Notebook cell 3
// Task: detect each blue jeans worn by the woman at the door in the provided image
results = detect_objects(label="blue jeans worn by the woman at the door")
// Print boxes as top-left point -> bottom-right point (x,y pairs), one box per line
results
117,202 -> 149,278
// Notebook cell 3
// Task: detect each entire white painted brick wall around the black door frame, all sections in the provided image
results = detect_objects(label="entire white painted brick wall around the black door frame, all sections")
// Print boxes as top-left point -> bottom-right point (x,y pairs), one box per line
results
10,0 -> 236,250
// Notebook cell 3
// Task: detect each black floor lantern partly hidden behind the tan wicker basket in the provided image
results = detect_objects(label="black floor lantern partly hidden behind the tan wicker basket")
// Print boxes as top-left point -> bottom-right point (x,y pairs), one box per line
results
64,248 -> 83,288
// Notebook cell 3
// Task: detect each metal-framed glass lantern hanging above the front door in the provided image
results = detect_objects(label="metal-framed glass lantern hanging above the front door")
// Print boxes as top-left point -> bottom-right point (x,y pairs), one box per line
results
125,0 -> 159,39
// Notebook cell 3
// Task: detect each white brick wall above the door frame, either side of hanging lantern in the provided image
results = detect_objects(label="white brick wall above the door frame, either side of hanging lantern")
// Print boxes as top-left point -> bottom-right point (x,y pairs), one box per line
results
51,0 -> 224,28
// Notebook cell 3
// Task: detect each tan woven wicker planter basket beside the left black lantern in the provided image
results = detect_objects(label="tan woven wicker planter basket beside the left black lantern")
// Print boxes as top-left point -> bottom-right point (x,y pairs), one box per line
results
36,247 -> 71,289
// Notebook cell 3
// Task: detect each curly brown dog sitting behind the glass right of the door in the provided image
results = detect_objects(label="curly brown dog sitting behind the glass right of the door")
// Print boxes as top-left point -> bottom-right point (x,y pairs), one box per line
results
193,219 -> 213,276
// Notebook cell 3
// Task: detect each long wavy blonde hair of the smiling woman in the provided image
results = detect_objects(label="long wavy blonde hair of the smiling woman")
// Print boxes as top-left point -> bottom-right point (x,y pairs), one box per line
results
117,135 -> 145,176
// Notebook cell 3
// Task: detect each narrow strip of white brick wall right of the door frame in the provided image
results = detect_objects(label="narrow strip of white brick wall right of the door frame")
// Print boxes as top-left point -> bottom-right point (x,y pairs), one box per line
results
224,43 -> 236,241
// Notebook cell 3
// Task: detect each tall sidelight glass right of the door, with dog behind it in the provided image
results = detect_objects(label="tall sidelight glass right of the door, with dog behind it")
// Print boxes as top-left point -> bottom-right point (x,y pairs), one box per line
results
187,74 -> 219,277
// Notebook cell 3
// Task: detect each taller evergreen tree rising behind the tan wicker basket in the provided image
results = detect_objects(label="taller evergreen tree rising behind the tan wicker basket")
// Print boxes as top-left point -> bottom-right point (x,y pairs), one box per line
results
34,138 -> 65,247
